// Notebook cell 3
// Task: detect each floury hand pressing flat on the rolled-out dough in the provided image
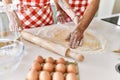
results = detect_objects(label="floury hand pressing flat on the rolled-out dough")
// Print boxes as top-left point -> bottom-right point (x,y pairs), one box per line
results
66,29 -> 83,49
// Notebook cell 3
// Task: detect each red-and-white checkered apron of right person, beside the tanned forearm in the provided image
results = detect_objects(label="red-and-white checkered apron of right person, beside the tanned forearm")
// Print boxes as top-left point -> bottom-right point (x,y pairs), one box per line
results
67,0 -> 88,22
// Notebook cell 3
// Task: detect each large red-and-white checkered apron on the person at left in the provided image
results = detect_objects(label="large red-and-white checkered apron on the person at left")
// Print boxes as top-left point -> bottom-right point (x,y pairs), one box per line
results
17,0 -> 54,28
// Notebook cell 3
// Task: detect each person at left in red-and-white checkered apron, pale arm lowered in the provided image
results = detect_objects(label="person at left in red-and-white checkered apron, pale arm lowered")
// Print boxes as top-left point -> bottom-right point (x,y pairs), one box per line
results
3,0 -> 54,31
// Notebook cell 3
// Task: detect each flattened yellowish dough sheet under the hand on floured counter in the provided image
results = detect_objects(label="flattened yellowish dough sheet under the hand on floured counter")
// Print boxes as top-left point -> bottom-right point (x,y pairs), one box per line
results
37,26 -> 103,53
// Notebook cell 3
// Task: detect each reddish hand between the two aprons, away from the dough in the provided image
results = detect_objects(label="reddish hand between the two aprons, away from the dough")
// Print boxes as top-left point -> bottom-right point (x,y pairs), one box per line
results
57,10 -> 67,23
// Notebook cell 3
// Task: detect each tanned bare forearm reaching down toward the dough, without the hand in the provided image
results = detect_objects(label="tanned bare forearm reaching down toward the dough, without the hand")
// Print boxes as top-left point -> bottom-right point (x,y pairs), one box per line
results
77,0 -> 99,32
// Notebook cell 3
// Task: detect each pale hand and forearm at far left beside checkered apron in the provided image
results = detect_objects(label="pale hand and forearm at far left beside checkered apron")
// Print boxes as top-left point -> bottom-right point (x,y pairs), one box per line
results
7,11 -> 23,31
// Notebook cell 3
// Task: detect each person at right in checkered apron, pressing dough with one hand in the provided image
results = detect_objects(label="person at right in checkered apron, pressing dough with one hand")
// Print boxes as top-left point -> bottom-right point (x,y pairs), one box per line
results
54,0 -> 99,49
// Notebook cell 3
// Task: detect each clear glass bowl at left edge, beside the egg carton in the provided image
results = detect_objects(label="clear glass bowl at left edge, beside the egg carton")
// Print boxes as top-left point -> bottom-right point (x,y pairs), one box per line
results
0,39 -> 24,75
